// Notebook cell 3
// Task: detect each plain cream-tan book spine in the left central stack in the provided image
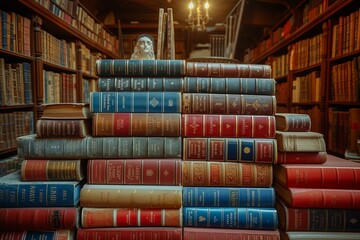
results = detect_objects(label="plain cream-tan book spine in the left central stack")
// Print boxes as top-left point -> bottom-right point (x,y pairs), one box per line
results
80,185 -> 182,208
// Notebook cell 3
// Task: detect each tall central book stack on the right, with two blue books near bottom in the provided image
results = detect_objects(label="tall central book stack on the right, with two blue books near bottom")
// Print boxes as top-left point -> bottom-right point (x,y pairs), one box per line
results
182,61 -> 280,240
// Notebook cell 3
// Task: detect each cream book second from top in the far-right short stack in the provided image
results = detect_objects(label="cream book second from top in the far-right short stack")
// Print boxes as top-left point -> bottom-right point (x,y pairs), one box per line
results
275,131 -> 326,152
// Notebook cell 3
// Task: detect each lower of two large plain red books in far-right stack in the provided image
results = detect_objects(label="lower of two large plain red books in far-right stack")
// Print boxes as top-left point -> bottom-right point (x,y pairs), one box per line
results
274,182 -> 360,209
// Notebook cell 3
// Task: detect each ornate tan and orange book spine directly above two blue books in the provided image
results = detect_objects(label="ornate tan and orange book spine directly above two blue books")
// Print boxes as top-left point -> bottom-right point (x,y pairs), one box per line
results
182,161 -> 273,187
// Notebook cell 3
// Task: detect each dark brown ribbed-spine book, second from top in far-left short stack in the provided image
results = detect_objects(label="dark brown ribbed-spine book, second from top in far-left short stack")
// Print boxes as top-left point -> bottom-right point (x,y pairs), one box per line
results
36,119 -> 91,138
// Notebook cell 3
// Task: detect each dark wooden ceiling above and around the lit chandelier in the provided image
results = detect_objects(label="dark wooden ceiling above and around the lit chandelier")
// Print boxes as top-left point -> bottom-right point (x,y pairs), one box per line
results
80,0 -> 301,58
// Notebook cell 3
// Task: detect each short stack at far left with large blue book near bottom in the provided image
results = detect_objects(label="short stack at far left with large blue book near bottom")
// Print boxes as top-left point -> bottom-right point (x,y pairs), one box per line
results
0,103 -> 91,239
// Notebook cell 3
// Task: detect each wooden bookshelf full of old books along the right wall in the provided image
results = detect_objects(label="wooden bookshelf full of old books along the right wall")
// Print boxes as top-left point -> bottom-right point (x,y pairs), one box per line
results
243,0 -> 360,156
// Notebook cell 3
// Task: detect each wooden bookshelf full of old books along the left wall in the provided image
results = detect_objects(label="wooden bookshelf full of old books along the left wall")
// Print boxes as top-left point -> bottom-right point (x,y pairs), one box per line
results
0,0 -> 119,158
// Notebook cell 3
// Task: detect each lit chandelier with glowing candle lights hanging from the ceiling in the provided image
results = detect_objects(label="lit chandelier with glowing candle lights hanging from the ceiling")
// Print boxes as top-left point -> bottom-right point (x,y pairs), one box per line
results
187,0 -> 210,31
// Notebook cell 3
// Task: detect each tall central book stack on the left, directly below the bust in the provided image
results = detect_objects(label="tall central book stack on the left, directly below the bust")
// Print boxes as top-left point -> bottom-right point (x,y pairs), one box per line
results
77,59 -> 185,240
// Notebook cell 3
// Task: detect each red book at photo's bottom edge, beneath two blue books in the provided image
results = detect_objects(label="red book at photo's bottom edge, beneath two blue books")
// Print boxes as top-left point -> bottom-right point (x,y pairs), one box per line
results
183,227 -> 280,240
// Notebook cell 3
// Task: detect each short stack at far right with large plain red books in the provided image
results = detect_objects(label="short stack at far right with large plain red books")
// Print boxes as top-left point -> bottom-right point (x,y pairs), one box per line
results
274,113 -> 360,240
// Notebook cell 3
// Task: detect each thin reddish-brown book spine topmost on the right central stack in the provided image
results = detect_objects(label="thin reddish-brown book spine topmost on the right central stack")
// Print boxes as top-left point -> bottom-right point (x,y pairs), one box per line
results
186,62 -> 271,78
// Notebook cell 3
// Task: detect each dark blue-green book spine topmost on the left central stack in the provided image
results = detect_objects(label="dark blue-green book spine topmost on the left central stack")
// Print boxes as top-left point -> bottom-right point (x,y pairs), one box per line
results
96,59 -> 185,77
